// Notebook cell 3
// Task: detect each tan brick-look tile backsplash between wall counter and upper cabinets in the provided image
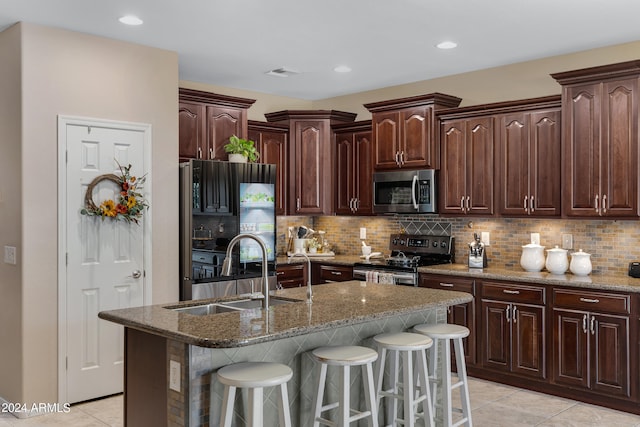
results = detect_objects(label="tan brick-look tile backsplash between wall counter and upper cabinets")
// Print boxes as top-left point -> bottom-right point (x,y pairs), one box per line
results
277,215 -> 640,274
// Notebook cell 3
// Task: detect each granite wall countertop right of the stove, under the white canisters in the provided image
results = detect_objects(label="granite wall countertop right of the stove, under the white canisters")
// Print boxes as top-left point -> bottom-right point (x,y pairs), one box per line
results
418,264 -> 640,292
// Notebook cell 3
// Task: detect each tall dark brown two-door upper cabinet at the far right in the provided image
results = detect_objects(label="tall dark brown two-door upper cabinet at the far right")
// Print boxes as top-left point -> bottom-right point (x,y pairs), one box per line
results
551,61 -> 640,218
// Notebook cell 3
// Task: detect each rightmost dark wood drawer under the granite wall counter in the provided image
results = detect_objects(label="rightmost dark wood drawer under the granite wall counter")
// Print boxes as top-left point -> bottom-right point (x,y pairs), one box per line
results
553,289 -> 631,314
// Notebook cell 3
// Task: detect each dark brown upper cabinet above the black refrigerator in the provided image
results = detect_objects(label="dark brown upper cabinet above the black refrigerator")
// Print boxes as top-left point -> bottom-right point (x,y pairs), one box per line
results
178,88 -> 255,161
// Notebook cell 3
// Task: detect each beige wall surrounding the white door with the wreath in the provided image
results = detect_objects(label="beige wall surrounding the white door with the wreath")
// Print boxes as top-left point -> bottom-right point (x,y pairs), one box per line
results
0,24 -> 179,403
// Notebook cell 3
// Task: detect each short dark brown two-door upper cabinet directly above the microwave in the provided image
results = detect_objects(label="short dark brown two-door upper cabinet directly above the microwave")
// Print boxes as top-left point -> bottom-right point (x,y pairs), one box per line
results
364,93 -> 461,170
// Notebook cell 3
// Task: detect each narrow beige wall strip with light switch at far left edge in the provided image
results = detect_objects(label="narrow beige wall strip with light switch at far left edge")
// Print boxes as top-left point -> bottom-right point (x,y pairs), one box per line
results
0,22 -> 24,402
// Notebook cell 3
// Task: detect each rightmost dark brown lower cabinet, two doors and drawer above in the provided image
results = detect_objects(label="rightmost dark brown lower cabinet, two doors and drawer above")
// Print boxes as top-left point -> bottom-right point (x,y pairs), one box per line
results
553,290 -> 631,398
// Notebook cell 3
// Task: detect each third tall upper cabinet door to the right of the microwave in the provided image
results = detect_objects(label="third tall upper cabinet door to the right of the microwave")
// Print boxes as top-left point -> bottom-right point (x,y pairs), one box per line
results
497,113 -> 530,216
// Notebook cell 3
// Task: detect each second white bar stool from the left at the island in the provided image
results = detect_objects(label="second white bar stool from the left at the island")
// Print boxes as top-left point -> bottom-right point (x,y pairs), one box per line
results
311,346 -> 378,427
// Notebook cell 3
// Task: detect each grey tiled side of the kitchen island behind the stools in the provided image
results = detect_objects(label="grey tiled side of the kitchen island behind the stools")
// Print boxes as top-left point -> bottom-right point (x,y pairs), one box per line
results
189,307 -> 446,427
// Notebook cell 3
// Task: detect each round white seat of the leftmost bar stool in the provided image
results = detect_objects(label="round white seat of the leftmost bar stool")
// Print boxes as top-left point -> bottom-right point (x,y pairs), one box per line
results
218,362 -> 293,388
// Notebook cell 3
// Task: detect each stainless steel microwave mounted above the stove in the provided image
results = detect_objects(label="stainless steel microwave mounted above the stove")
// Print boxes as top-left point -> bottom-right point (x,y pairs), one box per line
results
373,169 -> 438,213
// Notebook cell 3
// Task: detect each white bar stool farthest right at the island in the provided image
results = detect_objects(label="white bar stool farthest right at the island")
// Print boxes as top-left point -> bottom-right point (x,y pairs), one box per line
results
413,323 -> 473,427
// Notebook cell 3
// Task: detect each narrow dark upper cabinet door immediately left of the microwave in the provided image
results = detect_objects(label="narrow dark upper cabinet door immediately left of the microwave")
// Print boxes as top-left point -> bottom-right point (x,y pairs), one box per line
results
353,132 -> 373,215
